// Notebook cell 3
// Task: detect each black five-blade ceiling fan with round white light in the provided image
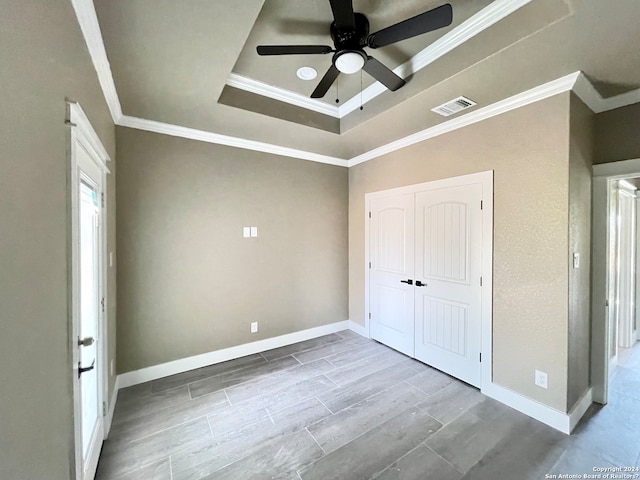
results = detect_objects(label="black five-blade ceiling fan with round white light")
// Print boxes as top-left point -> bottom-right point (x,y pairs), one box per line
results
256,0 -> 453,98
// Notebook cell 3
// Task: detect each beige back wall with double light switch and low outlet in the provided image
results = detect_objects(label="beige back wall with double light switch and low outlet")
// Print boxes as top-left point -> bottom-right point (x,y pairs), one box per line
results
117,127 -> 348,373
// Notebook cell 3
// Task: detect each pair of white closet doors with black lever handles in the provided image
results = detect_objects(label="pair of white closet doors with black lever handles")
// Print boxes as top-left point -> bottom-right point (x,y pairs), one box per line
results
369,179 -> 482,386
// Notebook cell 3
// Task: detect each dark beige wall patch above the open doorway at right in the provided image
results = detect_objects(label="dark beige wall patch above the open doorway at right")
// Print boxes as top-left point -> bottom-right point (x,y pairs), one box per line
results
593,103 -> 640,164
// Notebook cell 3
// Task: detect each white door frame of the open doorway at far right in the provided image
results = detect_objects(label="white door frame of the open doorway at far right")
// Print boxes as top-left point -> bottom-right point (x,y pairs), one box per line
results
591,158 -> 640,404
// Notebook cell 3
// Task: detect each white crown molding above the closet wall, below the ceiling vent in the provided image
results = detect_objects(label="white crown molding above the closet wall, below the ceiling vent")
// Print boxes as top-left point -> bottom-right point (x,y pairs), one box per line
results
349,72 -> 582,167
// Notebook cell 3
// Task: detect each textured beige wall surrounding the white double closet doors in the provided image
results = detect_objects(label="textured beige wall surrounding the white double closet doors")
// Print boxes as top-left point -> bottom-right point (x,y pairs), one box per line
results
349,93 -> 570,411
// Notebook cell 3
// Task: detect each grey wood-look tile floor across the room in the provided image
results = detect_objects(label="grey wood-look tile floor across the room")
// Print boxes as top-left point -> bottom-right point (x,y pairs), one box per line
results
96,331 -> 640,480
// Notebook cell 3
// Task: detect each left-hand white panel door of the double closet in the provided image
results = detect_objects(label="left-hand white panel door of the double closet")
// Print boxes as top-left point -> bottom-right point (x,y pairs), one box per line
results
369,194 -> 415,356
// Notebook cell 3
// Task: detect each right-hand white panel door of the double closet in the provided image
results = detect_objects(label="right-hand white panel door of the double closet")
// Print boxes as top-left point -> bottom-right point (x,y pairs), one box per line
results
415,183 -> 482,387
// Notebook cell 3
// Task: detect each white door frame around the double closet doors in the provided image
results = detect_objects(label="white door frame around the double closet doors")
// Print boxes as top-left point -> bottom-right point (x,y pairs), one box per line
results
364,170 -> 493,390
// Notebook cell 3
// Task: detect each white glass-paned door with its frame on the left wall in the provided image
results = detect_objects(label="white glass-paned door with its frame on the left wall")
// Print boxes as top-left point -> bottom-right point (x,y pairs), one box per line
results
69,104 -> 108,480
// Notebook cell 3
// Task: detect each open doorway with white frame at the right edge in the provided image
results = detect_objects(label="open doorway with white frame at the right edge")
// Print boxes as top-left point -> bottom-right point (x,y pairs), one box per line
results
591,159 -> 640,404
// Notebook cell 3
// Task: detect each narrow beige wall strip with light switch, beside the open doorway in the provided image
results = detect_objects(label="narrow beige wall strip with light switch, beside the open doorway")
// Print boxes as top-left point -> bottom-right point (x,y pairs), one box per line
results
567,94 -> 594,411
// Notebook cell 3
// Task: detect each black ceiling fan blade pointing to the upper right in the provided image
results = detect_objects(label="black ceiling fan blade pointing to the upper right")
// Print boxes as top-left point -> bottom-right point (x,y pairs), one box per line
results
367,3 -> 453,48
